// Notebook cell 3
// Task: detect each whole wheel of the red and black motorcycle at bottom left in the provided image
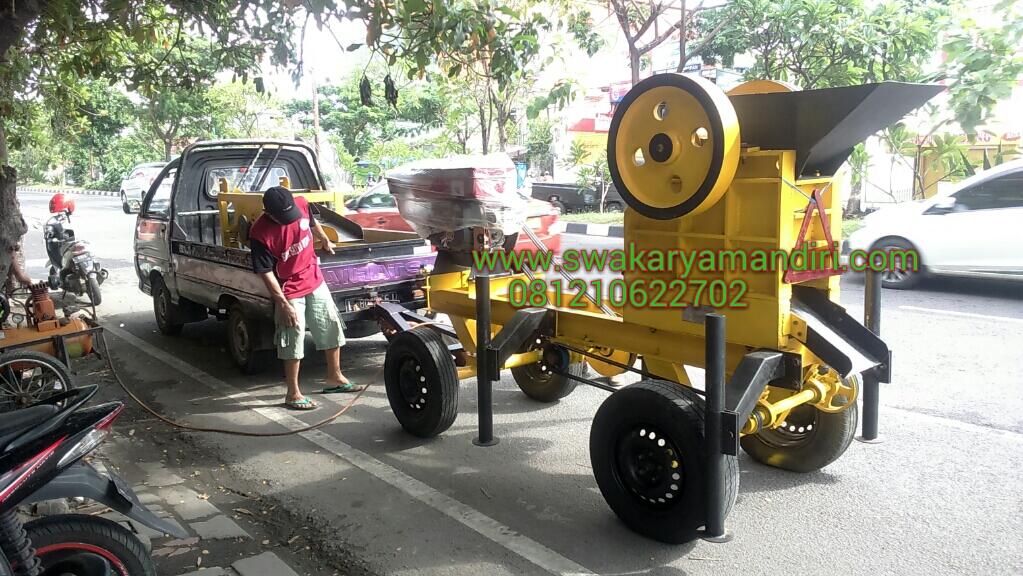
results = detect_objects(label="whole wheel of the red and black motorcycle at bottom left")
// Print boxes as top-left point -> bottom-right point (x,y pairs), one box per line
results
25,514 -> 157,576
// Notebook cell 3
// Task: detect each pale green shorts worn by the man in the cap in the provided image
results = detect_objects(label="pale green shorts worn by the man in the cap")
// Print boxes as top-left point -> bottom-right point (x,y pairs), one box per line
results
273,282 -> 345,360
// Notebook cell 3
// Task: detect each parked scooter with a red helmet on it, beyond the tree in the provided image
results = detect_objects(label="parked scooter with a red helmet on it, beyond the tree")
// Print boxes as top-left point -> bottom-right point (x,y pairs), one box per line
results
43,193 -> 109,306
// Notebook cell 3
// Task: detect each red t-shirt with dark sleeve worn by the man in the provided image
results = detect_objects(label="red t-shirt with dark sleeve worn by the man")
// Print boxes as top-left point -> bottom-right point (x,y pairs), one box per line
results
249,196 -> 323,300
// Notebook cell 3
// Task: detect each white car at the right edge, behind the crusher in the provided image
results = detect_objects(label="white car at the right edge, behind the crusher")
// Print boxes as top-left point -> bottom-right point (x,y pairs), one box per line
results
847,160 -> 1023,289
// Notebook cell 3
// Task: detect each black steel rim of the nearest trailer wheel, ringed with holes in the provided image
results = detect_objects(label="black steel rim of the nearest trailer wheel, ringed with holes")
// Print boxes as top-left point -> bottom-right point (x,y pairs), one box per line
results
614,425 -> 684,509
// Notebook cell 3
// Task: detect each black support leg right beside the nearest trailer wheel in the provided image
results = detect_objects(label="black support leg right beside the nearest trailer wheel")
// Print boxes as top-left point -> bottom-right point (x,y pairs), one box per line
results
703,314 -> 731,542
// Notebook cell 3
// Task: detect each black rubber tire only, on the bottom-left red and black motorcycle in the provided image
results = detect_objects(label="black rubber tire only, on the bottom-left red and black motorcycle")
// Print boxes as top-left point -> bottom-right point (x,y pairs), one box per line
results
25,514 -> 157,576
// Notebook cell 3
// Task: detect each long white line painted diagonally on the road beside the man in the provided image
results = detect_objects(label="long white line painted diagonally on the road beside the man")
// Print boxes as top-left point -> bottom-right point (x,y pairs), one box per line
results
104,326 -> 593,576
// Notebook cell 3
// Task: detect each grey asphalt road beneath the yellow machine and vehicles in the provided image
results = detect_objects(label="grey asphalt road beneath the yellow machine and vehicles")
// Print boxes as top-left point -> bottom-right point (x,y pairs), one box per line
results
14,194 -> 1023,575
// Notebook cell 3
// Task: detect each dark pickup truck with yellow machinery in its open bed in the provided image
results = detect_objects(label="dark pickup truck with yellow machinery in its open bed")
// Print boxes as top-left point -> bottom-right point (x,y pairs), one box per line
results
135,140 -> 436,372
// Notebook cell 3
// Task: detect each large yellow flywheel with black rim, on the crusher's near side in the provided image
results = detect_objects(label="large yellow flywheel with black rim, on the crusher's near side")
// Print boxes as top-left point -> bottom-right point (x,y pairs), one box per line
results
608,74 -> 740,220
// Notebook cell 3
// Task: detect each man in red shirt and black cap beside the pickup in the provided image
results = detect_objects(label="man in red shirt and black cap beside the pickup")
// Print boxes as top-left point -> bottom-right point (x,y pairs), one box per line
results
249,186 -> 354,410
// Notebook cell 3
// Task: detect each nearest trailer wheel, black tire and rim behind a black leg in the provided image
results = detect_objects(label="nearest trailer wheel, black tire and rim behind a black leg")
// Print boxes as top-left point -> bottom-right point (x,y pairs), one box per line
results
589,380 -> 739,544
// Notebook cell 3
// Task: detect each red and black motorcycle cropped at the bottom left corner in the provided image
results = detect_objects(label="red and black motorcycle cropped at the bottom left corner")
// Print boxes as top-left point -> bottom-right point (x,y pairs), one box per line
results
0,386 -> 187,576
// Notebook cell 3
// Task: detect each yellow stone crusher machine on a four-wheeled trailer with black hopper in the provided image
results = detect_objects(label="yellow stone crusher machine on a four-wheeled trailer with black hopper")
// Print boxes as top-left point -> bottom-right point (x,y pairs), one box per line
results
381,74 -> 940,542
